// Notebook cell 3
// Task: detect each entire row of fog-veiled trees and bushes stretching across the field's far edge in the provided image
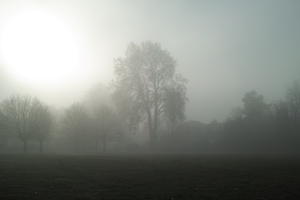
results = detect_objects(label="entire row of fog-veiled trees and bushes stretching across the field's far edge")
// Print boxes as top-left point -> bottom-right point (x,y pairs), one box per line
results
0,41 -> 300,153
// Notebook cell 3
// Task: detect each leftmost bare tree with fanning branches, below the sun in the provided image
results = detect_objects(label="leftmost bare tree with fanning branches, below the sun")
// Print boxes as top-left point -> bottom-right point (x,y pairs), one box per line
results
1,96 -> 33,152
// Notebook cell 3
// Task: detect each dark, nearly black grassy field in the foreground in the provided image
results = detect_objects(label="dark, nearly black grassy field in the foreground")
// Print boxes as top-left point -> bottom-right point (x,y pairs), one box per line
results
0,155 -> 300,200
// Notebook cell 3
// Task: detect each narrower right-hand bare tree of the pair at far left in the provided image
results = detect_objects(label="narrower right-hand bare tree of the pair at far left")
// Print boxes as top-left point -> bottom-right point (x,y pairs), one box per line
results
30,99 -> 53,152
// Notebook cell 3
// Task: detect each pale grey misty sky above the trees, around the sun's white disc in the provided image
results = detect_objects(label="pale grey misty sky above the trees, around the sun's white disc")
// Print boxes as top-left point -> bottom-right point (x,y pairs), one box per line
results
0,0 -> 300,122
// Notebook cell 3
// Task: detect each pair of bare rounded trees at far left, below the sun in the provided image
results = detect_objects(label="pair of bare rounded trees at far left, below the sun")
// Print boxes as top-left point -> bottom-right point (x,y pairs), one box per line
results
0,96 -> 53,152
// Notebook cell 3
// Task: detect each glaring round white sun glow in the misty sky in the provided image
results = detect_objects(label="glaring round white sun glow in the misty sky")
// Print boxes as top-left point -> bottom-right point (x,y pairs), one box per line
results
0,10 -> 85,87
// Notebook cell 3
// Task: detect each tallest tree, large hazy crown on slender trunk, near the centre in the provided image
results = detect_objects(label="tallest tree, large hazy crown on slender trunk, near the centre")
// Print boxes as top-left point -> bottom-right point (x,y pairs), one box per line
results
115,42 -> 183,146
